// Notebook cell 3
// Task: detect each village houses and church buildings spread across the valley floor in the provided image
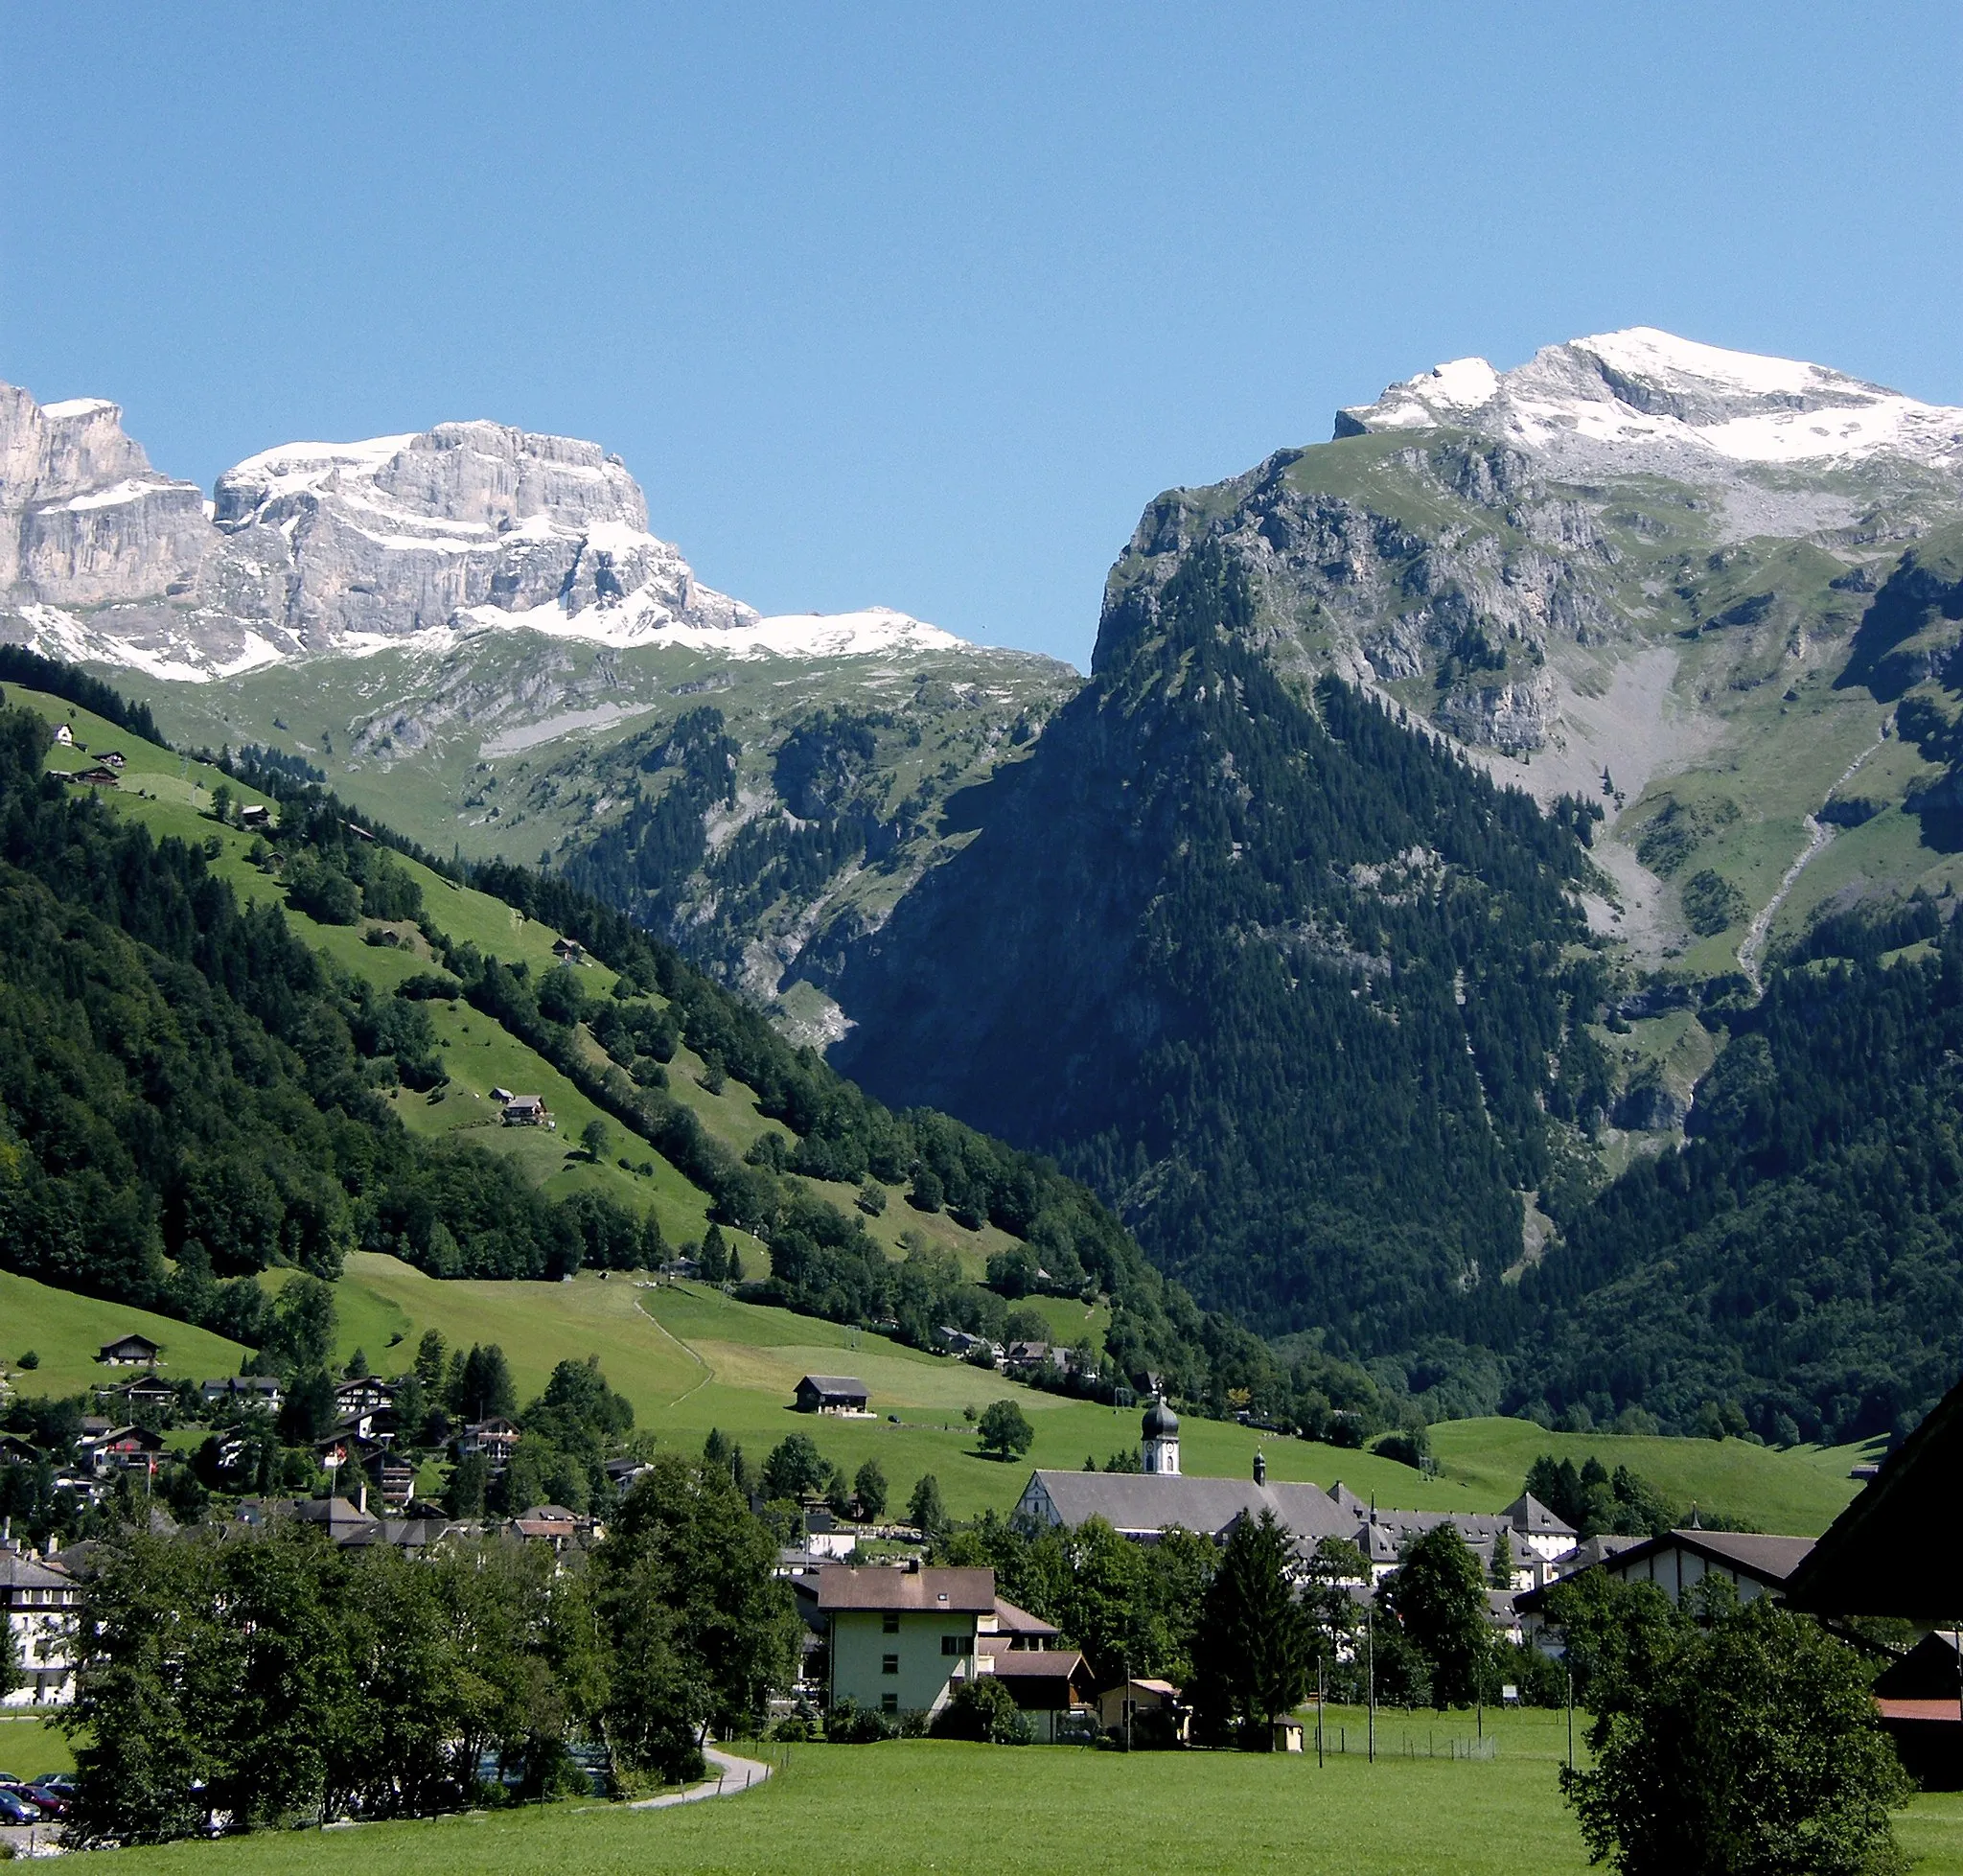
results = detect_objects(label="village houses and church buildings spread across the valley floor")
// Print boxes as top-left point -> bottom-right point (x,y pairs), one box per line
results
0,1332 -> 1963,1816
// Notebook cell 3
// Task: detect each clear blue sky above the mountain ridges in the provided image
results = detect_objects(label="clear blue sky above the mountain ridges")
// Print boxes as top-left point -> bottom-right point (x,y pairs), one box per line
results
0,0 -> 1963,665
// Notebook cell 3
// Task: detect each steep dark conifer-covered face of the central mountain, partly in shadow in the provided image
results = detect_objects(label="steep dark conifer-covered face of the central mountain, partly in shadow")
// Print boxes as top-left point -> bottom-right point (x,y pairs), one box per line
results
834,551 -> 1607,1348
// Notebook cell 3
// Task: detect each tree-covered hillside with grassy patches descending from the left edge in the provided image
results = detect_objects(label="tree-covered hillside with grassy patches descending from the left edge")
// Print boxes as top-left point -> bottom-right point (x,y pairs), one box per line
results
0,665 -> 1378,1415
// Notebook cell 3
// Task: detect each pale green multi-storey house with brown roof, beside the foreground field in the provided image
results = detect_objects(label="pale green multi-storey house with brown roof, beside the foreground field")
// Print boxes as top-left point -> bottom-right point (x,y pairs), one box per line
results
817,1564 -> 995,1713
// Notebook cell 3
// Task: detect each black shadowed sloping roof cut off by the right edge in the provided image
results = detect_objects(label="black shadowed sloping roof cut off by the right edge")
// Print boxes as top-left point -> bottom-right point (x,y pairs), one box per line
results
1787,1383 -> 1963,1621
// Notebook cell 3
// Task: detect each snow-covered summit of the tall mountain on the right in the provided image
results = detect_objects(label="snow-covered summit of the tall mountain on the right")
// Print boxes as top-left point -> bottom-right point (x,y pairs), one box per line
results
1337,326 -> 1963,473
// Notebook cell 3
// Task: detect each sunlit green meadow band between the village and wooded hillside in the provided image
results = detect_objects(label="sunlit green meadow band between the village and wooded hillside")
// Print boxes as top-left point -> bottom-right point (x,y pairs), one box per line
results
0,1252 -> 1863,1535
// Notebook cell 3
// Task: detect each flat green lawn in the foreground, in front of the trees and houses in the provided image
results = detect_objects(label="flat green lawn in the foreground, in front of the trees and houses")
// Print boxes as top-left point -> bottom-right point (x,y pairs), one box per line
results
72,1713 -> 1963,1876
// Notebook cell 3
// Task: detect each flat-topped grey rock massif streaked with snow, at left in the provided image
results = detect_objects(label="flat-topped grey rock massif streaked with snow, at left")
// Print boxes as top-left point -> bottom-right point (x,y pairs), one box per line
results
0,386 -> 959,681
